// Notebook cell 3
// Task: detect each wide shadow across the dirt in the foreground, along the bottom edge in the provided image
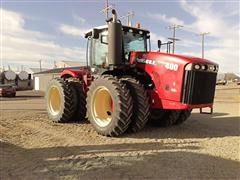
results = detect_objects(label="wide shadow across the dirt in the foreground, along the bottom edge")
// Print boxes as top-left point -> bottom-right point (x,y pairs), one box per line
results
0,142 -> 240,179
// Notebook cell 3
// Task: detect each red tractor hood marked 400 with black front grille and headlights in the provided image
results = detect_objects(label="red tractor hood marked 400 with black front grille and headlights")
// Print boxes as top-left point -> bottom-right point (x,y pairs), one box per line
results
130,52 -> 218,109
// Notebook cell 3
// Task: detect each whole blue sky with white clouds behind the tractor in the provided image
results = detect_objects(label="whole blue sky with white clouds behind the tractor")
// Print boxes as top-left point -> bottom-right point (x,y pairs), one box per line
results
0,0 -> 240,74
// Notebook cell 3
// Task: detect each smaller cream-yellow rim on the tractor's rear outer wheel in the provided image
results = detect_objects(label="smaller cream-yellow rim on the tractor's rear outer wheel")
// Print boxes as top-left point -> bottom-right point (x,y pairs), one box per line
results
48,86 -> 61,115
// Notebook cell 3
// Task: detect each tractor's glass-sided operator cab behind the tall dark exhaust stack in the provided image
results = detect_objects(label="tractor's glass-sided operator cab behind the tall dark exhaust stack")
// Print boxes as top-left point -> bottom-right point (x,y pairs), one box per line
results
85,25 -> 151,68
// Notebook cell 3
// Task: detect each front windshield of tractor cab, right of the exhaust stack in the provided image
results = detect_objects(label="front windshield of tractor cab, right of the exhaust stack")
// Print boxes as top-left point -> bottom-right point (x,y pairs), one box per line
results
123,32 -> 147,52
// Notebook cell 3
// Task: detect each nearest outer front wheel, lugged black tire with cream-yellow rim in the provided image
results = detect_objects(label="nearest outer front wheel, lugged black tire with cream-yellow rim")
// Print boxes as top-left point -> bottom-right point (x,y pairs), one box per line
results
87,75 -> 132,136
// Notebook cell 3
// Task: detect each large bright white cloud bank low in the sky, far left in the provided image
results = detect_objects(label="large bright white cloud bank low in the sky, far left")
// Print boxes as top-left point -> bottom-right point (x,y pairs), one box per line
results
0,9 -> 85,68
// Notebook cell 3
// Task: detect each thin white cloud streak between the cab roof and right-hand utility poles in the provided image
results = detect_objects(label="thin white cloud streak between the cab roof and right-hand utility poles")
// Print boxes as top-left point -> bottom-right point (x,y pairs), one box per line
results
148,13 -> 184,25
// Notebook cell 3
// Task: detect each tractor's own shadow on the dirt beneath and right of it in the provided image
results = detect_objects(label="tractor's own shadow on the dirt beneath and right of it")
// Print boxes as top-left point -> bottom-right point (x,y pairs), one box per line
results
123,113 -> 240,139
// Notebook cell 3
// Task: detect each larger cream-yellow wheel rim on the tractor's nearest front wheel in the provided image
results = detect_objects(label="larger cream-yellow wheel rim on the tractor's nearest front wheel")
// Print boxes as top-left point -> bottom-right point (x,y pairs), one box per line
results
91,86 -> 113,127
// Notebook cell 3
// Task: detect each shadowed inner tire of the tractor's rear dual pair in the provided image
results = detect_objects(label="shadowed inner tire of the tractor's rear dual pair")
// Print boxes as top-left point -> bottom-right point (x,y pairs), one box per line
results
70,81 -> 87,121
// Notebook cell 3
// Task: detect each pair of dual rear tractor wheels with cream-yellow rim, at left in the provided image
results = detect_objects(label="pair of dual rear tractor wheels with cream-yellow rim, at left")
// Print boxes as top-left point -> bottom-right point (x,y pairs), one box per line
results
45,78 -> 86,123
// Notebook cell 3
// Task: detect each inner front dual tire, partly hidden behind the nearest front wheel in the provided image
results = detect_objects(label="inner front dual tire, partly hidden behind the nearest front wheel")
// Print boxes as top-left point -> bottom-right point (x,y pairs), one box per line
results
121,77 -> 150,132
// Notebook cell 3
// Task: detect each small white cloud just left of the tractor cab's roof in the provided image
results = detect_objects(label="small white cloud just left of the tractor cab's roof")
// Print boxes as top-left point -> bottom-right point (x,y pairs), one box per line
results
59,24 -> 88,38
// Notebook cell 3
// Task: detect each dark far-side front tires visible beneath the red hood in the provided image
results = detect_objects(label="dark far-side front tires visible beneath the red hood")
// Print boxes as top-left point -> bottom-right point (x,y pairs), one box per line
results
151,109 -> 181,127
